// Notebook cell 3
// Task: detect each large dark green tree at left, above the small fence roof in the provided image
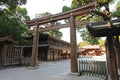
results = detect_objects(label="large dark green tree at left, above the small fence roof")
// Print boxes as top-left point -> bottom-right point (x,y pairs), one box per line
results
0,0 -> 29,44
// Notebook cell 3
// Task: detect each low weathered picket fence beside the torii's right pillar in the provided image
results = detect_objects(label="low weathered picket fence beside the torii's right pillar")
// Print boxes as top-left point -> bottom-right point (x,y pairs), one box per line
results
79,60 -> 108,80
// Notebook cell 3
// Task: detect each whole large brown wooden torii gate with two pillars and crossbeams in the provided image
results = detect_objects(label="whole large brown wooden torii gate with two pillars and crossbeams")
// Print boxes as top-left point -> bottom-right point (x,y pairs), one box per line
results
27,1 -> 96,72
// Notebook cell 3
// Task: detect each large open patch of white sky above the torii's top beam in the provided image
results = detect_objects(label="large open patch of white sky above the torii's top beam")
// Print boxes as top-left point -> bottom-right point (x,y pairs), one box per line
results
24,0 -> 72,19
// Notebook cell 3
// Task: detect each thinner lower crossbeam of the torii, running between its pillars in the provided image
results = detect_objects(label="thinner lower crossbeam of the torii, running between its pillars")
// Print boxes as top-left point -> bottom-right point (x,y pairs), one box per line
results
28,20 -> 89,33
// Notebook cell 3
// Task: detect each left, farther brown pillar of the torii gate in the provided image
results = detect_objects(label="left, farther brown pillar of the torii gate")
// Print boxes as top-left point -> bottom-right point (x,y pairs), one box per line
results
31,25 -> 39,67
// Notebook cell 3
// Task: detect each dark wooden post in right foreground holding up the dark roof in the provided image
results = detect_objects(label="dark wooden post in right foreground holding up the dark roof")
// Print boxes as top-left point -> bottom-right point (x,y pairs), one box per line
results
107,36 -> 118,80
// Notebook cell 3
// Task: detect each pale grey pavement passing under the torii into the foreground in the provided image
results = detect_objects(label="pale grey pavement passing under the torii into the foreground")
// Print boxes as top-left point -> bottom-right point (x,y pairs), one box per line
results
0,60 -> 104,80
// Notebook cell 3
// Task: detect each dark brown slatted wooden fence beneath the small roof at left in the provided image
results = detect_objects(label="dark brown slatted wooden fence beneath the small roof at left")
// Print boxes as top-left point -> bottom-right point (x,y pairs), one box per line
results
1,46 -> 22,66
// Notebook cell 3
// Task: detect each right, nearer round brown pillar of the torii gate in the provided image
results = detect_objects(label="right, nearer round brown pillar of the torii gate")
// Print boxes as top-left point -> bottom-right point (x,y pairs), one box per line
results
70,15 -> 78,73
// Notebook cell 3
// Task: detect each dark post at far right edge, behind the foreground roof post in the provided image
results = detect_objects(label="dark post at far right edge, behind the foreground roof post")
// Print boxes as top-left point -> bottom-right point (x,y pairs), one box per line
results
115,36 -> 120,68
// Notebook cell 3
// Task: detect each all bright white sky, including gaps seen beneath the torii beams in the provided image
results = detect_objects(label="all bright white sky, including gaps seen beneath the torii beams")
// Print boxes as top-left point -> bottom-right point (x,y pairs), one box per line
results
23,0 -> 118,43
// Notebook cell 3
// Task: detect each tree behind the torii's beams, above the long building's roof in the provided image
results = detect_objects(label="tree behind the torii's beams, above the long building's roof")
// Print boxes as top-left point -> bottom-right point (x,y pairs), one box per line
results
35,12 -> 62,38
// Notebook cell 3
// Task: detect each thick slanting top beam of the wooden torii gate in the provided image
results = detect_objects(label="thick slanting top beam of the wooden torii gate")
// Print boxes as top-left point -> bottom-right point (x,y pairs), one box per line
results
26,1 -> 96,26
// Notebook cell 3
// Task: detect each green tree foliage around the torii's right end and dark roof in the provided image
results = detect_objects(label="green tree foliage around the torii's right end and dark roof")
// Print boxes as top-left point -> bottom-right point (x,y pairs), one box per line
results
62,0 -> 114,45
